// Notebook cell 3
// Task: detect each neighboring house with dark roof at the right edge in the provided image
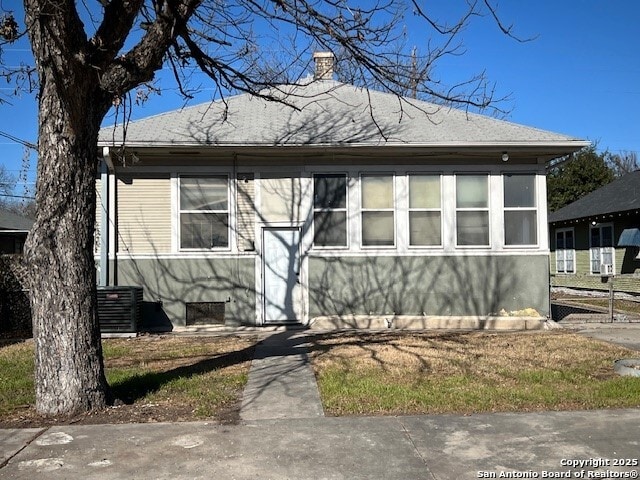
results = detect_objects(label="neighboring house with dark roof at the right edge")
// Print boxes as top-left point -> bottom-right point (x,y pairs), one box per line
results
549,170 -> 640,293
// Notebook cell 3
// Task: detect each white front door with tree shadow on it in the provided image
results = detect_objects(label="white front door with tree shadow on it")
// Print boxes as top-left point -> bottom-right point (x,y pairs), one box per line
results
262,228 -> 302,323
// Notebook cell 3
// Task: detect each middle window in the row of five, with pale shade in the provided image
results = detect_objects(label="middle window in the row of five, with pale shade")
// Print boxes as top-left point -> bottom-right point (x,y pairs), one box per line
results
409,174 -> 442,247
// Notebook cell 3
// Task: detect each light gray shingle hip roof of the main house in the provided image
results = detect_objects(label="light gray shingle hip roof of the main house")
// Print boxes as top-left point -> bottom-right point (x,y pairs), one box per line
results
99,80 -> 586,151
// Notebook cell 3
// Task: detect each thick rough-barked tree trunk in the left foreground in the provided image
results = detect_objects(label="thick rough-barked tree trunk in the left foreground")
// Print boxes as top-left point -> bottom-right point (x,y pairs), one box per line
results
25,0 -> 110,416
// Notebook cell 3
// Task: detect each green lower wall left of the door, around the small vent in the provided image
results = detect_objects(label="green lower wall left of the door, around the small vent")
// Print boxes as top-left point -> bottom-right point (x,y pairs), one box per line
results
118,256 -> 256,327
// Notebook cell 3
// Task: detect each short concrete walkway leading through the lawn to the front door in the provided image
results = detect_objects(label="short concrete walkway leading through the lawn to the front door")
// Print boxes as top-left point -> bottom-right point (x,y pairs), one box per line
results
240,330 -> 323,421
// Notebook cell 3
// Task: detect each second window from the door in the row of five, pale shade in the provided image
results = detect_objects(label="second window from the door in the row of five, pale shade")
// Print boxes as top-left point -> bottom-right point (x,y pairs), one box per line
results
360,174 -> 395,247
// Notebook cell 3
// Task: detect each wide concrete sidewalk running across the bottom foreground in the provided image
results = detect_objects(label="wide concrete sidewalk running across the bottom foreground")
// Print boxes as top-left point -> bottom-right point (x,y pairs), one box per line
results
0,409 -> 640,480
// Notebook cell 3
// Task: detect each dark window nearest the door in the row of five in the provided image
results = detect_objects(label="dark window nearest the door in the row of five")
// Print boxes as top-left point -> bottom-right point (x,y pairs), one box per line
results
313,173 -> 347,247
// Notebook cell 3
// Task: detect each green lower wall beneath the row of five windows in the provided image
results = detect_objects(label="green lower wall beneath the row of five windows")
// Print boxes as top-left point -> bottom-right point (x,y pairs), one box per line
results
309,255 -> 549,318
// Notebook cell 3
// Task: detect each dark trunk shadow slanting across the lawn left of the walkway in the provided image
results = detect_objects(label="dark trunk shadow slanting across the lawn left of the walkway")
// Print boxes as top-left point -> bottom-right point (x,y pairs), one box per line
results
111,344 -> 256,405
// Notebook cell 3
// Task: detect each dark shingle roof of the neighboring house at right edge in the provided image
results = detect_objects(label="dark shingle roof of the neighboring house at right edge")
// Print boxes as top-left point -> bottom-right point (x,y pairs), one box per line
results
549,170 -> 640,223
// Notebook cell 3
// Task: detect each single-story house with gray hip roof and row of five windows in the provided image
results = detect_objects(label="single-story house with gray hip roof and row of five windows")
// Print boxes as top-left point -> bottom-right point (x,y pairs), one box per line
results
96,52 -> 588,327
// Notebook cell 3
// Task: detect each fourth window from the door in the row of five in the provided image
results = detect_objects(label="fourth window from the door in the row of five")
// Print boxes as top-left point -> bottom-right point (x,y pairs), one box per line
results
456,174 -> 489,247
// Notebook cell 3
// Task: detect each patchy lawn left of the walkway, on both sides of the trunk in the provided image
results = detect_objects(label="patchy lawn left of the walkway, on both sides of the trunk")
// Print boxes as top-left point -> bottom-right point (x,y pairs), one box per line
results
0,336 -> 256,424
